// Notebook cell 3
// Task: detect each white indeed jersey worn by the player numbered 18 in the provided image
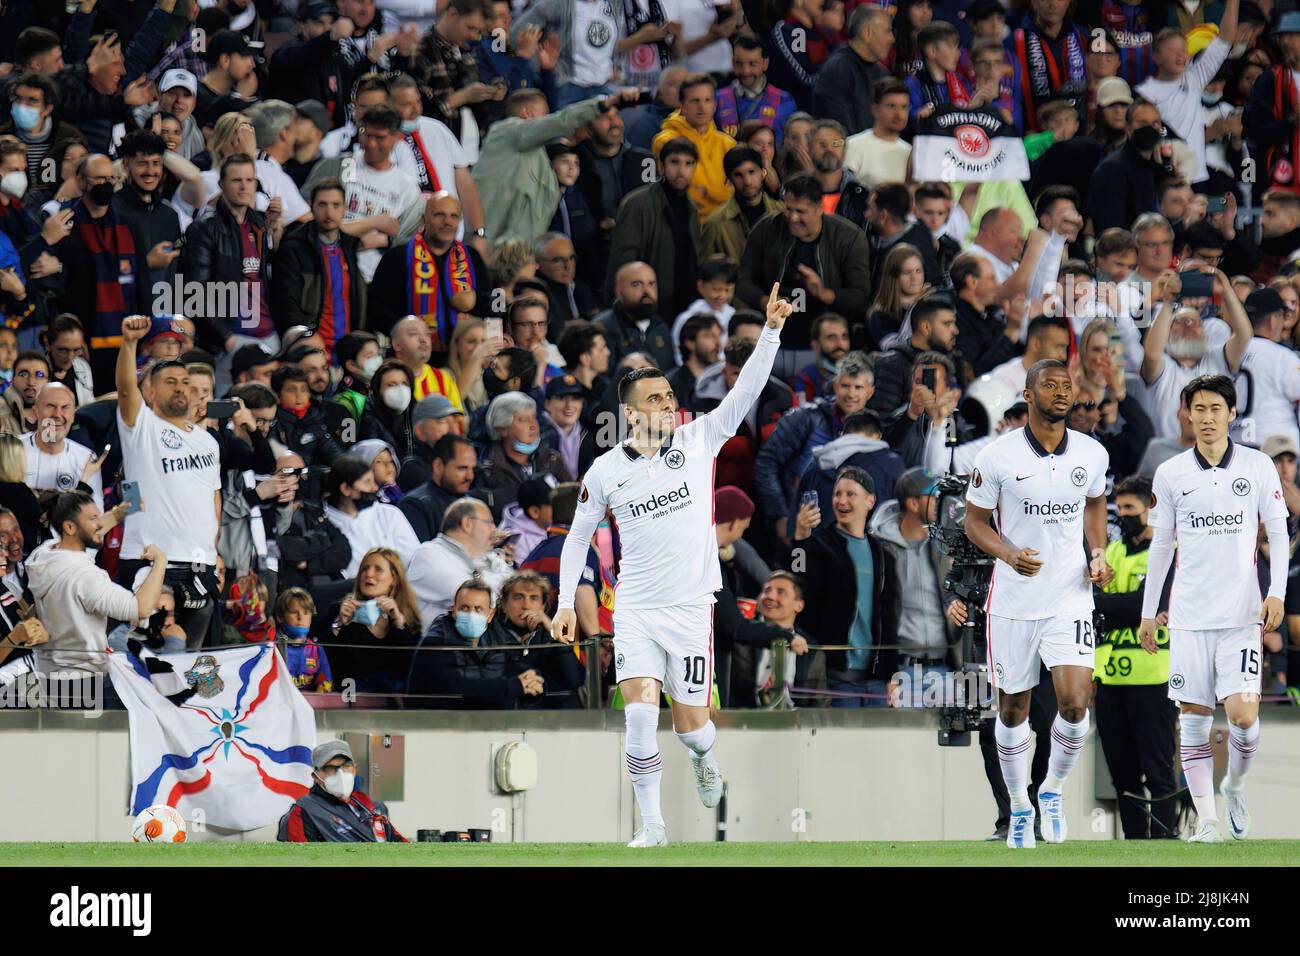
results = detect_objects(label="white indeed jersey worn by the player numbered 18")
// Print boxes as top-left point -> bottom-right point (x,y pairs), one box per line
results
966,427 -> 1110,620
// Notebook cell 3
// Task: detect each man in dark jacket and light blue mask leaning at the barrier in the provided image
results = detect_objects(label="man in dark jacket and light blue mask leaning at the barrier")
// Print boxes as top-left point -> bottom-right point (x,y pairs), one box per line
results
407,578 -> 553,710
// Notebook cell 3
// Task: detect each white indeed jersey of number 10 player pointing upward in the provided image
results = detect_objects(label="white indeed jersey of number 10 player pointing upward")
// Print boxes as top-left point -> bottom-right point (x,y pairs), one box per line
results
559,328 -> 781,610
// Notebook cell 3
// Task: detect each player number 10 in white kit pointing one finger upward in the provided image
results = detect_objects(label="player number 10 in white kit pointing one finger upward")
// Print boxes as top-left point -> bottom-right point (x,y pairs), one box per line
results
553,285 -> 793,847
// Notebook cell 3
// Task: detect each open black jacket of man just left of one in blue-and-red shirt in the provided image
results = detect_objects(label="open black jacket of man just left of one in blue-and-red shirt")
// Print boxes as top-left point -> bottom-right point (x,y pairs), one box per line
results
179,199 -> 272,355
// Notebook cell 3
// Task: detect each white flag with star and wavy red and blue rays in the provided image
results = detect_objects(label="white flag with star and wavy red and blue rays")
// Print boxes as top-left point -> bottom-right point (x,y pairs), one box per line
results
109,644 -> 316,831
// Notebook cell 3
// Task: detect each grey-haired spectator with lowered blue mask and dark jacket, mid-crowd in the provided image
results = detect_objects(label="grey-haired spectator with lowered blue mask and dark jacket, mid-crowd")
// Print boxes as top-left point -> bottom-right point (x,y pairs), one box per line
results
475,392 -> 573,520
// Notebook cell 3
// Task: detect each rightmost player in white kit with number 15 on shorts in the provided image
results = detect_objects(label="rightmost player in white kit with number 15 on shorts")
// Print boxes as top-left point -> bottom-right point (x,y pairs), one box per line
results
1138,375 -> 1290,843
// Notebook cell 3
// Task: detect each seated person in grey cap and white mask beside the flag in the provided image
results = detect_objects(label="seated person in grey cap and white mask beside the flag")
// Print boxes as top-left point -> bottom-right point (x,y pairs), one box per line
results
276,740 -> 410,843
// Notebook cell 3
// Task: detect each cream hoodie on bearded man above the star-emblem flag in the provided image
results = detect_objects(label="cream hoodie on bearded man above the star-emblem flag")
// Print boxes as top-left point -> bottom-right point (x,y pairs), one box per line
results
27,541 -> 140,674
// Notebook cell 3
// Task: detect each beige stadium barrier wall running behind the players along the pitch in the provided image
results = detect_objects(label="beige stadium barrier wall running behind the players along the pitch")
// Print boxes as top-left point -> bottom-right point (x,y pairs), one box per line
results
0,708 -> 1300,843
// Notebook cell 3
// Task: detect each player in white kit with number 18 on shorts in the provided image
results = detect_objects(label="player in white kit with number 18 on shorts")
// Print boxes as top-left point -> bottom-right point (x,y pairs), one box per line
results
966,359 -> 1107,848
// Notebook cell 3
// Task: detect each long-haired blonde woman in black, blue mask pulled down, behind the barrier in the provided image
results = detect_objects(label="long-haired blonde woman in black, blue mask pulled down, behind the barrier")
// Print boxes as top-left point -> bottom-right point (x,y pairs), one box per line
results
330,548 -> 420,693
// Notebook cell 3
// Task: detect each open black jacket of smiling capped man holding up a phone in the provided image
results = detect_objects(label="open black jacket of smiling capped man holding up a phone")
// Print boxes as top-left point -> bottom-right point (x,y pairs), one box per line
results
796,524 -> 898,680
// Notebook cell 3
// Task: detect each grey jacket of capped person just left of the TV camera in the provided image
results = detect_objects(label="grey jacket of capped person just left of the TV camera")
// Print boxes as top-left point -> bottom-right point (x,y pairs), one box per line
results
867,498 -> 948,658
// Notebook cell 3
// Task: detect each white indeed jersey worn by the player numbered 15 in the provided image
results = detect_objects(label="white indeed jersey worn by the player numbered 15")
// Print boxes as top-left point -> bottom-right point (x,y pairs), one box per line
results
1148,442 -> 1287,631
